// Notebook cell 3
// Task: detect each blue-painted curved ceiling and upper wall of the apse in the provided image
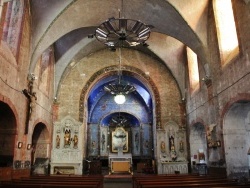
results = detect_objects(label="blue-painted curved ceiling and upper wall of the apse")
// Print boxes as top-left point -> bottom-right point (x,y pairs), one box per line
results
88,75 -> 153,126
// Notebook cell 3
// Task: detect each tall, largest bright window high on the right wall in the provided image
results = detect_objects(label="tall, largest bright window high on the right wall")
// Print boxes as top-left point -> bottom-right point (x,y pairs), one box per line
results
213,0 -> 239,65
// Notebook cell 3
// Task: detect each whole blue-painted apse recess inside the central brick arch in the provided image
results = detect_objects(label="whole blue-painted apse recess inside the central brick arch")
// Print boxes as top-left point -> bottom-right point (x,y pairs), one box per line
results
86,70 -> 154,173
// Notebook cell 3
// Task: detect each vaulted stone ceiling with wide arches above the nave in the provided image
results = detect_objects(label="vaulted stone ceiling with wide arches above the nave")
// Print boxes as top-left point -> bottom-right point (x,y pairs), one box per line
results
30,0 -> 211,97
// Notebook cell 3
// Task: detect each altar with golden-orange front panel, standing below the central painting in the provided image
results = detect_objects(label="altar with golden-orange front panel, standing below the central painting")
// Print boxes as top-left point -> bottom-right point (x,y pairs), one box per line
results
109,152 -> 133,174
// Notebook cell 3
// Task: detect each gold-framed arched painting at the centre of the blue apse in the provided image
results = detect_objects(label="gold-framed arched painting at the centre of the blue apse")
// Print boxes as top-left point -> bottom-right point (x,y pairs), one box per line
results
111,127 -> 128,152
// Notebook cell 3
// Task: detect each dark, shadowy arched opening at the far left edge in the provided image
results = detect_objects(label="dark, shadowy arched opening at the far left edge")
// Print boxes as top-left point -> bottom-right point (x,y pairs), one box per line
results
0,101 -> 16,167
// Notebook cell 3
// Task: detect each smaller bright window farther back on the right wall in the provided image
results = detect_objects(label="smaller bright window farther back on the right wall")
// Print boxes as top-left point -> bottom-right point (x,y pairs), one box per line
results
187,47 -> 200,92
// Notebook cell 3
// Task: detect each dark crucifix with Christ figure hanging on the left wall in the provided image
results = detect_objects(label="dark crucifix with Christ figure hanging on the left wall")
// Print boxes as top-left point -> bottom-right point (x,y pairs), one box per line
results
22,74 -> 37,134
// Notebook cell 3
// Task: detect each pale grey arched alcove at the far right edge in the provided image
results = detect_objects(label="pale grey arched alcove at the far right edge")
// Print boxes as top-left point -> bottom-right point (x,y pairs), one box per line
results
223,100 -> 250,178
